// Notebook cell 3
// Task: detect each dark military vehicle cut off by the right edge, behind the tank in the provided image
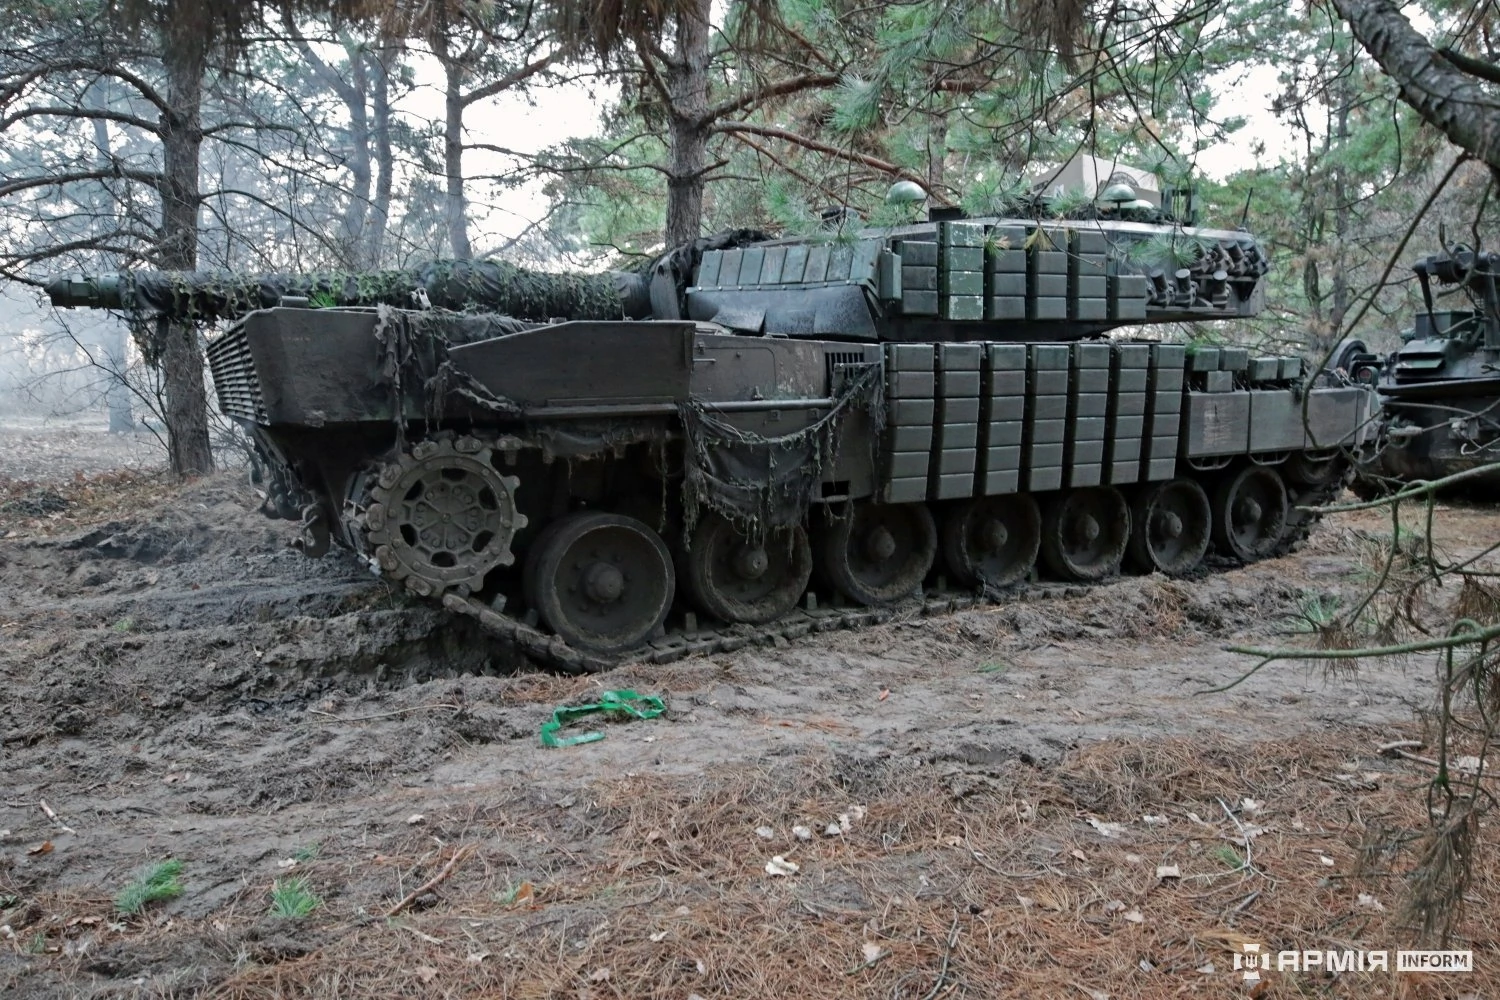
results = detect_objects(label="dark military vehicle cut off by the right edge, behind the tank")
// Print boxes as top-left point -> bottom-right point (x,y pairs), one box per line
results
1329,246 -> 1500,499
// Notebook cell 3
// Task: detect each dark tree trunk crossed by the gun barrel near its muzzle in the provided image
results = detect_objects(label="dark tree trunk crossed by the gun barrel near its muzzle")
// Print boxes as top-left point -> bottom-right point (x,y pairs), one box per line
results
155,18 -> 213,477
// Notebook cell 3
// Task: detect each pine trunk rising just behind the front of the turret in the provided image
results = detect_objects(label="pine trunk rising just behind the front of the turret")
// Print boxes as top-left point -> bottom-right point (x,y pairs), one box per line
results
663,0 -> 713,246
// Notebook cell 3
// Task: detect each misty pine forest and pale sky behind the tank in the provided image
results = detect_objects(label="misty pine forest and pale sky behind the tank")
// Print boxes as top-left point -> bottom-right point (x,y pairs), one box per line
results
0,0 -> 1500,472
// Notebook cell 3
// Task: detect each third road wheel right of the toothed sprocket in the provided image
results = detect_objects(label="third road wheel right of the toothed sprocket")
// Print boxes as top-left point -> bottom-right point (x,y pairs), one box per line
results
818,501 -> 938,604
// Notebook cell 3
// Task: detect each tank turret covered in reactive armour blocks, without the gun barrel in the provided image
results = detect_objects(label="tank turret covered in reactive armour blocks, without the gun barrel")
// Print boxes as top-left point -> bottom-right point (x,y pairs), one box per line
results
686,219 -> 1269,340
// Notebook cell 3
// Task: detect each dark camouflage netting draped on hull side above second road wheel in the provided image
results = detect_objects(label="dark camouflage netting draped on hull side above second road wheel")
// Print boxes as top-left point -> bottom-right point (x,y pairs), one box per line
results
678,364 -> 885,540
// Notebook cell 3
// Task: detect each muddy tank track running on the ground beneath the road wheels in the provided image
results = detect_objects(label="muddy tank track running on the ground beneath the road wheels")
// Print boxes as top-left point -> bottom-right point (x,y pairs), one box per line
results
443,477 -> 1347,673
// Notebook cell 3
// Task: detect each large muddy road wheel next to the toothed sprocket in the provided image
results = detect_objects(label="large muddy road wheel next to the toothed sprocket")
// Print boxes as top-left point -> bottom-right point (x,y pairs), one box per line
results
525,511 -> 677,652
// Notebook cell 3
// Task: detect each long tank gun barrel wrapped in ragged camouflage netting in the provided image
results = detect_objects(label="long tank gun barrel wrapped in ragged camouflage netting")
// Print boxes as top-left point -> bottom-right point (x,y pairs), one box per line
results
47,261 -> 651,321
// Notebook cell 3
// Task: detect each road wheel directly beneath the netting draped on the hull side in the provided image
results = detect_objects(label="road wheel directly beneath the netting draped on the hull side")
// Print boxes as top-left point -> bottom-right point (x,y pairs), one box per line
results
683,514 -> 813,624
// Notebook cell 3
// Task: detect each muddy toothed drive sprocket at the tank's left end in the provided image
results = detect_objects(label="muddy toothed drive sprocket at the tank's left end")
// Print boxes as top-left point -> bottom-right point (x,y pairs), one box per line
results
365,436 -> 527,597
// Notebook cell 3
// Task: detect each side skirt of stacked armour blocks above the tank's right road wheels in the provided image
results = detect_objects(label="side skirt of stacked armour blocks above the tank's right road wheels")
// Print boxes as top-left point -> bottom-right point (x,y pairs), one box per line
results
879,342 -> 1374,504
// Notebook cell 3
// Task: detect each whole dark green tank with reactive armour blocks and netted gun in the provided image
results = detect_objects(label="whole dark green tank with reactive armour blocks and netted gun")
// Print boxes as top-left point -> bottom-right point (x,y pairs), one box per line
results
50,213 -> 1374,669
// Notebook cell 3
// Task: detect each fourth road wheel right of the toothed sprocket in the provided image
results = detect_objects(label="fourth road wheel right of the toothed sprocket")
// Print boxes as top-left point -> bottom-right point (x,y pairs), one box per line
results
942,493 -> 1041,589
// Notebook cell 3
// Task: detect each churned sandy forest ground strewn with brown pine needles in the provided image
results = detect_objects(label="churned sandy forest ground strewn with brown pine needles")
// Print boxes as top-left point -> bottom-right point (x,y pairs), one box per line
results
0,429 -> 1500,1000
